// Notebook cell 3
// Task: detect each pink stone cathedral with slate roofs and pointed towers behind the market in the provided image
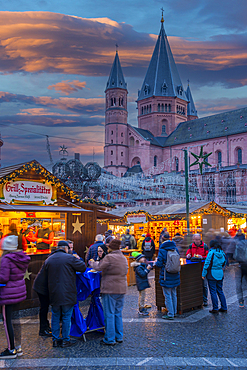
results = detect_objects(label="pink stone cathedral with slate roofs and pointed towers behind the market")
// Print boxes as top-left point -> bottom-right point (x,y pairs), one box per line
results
104,16 -> 247,203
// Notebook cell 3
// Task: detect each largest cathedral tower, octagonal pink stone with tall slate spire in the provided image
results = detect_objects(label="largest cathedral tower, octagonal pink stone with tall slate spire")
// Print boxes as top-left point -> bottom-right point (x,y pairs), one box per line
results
137,14 -> 188,136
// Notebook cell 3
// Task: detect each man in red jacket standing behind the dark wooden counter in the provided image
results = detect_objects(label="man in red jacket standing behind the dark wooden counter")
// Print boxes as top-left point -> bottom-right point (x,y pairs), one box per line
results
186,234 -> 209,306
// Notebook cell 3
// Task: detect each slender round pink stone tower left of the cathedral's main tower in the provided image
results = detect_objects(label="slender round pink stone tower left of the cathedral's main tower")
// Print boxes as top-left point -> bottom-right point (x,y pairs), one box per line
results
104,51 -> 129,177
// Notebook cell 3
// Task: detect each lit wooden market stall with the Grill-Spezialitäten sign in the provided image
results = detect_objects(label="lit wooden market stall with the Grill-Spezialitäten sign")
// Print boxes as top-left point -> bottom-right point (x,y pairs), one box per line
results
0,160 -> 115,308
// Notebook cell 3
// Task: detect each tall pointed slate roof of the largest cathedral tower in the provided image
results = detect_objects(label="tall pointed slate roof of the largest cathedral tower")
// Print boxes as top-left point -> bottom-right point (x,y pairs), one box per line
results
137,18 -> 188,101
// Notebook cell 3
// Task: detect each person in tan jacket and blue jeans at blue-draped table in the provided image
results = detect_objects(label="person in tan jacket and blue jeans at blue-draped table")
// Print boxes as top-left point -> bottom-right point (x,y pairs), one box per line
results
89,239 -> 128,346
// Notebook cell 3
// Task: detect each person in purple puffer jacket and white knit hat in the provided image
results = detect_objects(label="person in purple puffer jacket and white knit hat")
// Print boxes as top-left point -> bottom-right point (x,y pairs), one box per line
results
0,235 -> 30,360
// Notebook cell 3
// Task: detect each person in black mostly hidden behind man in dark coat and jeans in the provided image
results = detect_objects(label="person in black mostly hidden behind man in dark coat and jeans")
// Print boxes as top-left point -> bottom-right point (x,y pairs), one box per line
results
33,264 -> 52,337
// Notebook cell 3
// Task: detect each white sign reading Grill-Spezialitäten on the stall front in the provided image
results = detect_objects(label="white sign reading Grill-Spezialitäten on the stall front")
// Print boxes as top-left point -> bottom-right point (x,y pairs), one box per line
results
3,180 -> 55,204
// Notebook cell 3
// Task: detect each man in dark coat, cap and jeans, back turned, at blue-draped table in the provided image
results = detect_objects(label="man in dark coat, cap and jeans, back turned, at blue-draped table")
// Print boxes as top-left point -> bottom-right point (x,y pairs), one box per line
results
45,240 -> 86,348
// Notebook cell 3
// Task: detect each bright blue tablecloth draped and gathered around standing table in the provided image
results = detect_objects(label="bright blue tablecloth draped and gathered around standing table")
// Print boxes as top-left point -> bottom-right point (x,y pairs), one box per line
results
70,268 -> 105,337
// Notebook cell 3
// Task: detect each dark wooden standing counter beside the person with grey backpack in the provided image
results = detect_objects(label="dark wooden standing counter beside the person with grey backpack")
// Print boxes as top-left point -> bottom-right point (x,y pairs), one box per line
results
155,259 -> 203,315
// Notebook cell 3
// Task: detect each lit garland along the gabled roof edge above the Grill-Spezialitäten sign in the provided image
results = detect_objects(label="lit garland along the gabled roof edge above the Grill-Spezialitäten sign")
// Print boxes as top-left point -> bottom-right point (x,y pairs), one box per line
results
0,160 -> 115,208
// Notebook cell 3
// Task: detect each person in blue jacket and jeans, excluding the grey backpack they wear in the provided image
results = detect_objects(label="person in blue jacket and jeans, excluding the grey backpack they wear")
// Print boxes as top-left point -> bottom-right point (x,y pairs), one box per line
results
155,232 -> 180,320
